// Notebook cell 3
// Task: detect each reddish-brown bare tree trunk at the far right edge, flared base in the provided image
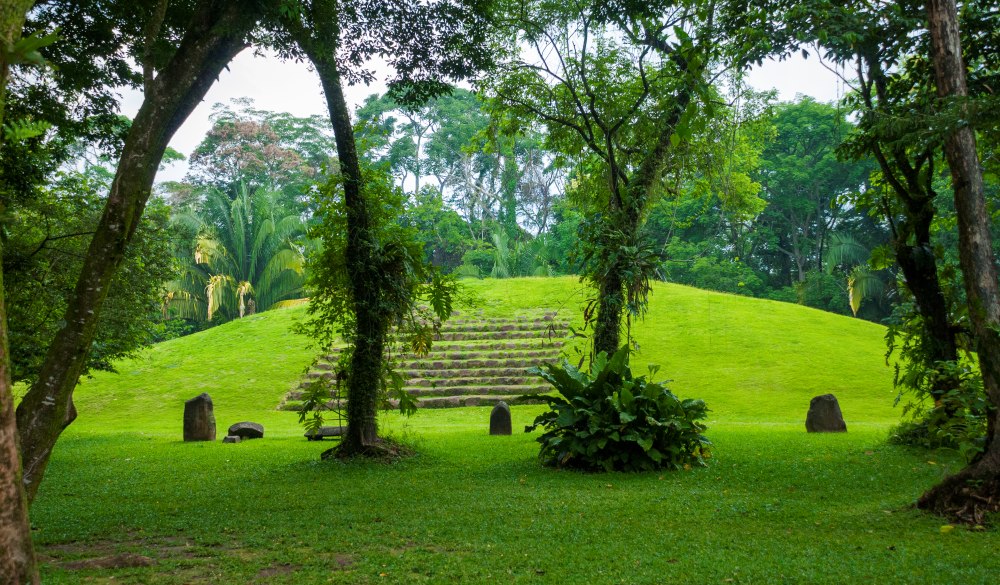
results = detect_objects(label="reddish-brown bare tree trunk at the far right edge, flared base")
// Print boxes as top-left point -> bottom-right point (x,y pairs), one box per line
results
917,0 -> 1000,524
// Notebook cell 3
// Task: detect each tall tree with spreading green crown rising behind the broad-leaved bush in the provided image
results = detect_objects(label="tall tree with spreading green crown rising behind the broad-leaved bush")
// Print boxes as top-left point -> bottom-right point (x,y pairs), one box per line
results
491,0 -> 718,355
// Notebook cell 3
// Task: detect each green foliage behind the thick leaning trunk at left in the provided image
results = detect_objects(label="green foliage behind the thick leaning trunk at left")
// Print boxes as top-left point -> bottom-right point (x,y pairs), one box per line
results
3,168 -> 176,382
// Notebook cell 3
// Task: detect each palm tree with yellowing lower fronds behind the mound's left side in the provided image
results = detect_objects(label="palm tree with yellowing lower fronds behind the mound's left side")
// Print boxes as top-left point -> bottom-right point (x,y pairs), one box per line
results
164,186 -> 307,321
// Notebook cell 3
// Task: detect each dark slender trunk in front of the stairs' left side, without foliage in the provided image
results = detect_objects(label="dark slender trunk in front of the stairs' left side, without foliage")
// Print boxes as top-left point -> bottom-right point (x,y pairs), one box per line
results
286,0 -> 388,456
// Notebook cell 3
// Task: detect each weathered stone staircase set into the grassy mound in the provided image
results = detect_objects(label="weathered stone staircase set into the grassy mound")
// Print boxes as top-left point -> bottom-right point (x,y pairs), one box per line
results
278,311 -> 569,410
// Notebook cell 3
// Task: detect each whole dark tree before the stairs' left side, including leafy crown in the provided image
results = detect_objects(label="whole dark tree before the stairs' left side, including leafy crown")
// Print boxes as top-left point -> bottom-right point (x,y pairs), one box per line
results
279,0 -> 489,456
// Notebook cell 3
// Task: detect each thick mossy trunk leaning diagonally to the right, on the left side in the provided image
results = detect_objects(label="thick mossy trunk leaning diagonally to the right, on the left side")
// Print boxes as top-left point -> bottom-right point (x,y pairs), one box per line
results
17,0 -> 257,501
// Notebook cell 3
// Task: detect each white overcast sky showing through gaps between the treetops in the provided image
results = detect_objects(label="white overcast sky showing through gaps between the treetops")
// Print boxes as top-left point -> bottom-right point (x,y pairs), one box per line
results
131,50 -> 845,181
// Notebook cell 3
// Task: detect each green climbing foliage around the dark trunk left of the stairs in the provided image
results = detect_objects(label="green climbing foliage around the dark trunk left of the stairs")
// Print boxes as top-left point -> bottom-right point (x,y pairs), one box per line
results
297,165 -> 460,427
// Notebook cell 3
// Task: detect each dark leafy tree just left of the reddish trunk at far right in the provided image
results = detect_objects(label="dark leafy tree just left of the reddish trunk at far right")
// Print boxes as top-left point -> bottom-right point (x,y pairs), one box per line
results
786,0 -> 961,416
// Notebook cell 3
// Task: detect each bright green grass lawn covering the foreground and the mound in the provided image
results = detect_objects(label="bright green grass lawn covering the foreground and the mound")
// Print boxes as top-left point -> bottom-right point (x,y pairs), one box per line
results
31,278 -> 1000,583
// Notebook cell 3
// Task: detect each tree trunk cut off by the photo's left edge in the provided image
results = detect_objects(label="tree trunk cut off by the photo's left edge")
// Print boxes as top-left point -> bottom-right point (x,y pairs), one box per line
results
0,0 -> 38,585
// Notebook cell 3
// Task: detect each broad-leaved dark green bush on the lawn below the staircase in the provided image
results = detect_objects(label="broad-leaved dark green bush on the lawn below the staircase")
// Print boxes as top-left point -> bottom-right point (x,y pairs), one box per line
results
525,348 -> 711,471
